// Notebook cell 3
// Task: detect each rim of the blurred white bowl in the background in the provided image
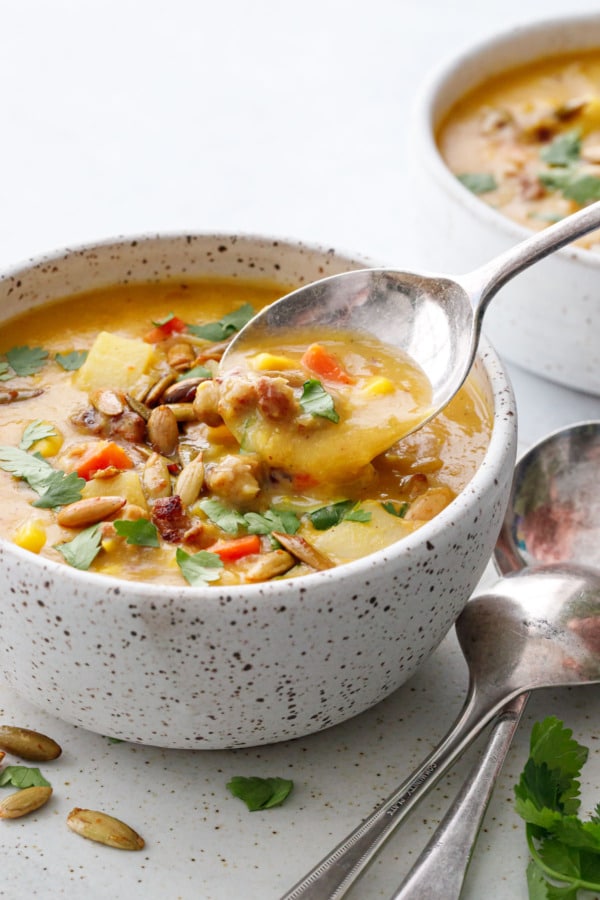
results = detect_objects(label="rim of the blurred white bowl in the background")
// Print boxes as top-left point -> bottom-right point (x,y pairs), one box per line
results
411,11 -> 600,269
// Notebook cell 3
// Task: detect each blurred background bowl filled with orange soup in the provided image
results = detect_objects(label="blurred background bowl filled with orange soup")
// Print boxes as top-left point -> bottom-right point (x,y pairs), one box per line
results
411,15 -> 600,394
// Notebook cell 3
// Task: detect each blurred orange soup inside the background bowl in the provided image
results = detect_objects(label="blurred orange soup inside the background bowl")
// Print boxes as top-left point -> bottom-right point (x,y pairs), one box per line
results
437,51 -> 600,250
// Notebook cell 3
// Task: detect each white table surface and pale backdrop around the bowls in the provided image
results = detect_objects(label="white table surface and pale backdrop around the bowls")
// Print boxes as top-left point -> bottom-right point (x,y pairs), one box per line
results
0,0 -> 600,900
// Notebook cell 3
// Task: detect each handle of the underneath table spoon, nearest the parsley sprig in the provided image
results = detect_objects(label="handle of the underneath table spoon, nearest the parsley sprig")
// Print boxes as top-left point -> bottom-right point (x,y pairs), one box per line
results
390,694 -> 529,900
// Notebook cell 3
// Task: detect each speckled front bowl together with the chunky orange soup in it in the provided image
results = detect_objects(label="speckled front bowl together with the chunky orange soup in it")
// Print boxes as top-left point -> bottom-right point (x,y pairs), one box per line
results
0,234 -> 516,748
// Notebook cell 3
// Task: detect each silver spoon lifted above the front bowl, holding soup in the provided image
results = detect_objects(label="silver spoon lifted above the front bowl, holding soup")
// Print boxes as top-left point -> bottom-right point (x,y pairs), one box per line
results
220,202 -> 600,461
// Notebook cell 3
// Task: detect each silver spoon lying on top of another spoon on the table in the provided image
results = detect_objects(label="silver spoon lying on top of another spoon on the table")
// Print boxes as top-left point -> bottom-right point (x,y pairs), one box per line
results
282,423 -> 600,900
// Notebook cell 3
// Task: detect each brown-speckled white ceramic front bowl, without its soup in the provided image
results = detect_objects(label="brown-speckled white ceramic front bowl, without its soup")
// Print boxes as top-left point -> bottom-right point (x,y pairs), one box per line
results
0,235 -> 516,748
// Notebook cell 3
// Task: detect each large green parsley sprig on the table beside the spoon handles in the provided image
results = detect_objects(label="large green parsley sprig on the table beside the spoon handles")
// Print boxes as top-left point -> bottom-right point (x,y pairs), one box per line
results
515,716 -> 600,900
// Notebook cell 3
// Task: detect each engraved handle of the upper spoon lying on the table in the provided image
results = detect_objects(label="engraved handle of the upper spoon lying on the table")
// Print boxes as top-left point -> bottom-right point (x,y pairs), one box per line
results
280,685 -> 515,900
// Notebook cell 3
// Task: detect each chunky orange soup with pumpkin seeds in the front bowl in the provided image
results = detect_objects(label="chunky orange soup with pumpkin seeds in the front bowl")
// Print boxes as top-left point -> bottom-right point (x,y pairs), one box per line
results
0,280 -> 491,585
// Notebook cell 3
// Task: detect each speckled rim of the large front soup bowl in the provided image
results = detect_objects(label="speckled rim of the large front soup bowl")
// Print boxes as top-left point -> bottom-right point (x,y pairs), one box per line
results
0,230 -> 517,603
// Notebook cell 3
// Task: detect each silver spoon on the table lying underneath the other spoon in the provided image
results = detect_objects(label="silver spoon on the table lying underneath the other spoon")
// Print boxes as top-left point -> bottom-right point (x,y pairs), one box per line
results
392,422 -> 600,900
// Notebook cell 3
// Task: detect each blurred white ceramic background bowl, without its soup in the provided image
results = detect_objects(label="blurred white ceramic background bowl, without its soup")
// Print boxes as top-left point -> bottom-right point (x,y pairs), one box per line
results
410,14 -> 600,394
